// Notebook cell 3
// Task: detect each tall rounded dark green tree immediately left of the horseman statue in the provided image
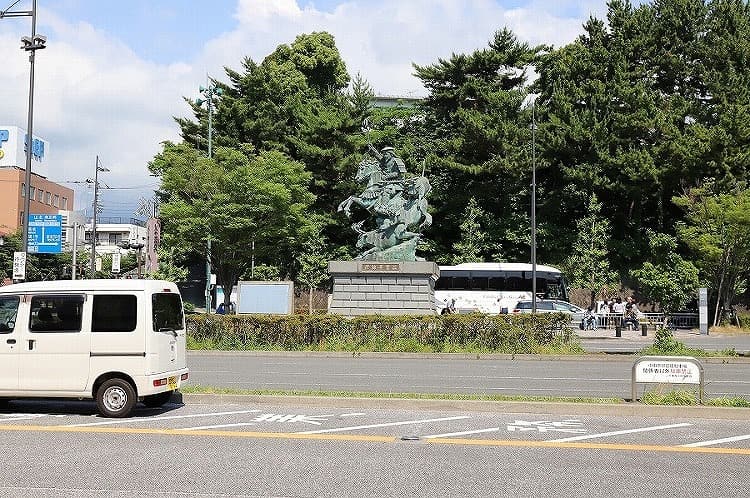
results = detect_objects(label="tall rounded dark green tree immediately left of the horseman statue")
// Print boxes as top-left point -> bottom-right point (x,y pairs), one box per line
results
177,32 -> 362,253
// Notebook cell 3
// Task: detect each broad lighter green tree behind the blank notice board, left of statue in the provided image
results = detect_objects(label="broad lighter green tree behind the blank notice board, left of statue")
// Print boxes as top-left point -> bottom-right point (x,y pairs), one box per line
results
149,143 -> 314,305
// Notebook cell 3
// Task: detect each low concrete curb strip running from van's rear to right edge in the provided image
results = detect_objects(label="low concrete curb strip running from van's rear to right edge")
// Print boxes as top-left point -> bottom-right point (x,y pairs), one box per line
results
172,393 -> 750,420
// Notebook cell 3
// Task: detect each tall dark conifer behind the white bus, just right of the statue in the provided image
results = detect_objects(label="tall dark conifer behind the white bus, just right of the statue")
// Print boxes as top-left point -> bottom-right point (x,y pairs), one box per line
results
415,29 -> 546,259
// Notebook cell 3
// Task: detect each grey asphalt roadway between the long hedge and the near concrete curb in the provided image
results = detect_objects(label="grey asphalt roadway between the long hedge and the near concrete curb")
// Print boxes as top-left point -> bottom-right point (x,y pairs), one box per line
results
188,351 -> 750,399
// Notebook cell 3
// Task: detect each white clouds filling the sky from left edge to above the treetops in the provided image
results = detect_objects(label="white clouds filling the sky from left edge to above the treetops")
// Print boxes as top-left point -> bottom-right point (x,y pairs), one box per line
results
0,0 -> 603,217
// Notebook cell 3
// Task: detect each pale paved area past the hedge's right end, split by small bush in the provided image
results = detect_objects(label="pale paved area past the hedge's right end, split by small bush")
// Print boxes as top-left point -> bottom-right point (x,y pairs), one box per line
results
575,329 -> 750,356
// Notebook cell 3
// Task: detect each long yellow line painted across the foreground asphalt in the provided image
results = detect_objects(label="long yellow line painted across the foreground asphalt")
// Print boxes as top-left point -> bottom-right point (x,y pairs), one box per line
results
0,425 -> 750,455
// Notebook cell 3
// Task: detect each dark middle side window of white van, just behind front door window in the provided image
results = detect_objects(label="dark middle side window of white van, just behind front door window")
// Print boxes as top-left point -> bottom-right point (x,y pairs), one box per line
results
29,294 -> 83,332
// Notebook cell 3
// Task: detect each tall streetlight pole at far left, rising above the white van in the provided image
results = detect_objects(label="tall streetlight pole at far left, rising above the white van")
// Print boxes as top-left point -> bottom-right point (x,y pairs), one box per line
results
0,0 -> 47,276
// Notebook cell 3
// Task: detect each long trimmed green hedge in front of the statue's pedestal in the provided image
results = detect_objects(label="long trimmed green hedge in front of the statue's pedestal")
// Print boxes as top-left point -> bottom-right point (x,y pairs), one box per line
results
187,313 -> 571,353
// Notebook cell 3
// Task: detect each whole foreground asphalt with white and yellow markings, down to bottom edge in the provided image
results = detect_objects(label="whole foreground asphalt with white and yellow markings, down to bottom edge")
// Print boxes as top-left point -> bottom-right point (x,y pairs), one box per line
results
0,401 -> 750,498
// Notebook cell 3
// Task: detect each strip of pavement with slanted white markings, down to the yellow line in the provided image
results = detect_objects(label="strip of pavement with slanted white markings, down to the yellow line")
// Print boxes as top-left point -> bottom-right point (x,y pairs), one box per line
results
0,400 -> 750,455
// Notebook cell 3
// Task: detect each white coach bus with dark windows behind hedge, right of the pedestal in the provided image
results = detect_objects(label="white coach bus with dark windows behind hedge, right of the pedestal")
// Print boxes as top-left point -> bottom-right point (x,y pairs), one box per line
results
435,263 -> 568,314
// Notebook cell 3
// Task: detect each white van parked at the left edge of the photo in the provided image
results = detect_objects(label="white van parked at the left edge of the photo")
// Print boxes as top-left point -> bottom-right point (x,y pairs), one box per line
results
0,280 -> 188,417
